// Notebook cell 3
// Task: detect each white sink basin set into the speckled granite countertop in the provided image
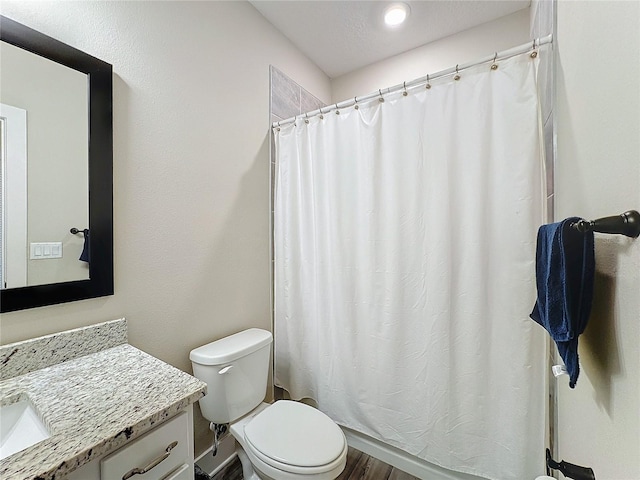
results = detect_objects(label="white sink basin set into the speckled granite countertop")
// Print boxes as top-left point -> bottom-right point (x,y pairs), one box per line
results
0,395 -> 51,460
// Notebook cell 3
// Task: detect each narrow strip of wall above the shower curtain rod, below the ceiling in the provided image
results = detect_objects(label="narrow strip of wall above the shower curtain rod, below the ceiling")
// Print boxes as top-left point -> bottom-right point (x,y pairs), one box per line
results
331,8 -> 530,103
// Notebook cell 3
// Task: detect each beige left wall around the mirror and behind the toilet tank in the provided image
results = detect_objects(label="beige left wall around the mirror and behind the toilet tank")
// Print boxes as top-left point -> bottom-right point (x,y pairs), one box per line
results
0,0 -> 330,453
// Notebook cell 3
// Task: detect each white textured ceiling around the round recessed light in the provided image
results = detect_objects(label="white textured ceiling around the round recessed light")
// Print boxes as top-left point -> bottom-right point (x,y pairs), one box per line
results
249,0 -> 530,78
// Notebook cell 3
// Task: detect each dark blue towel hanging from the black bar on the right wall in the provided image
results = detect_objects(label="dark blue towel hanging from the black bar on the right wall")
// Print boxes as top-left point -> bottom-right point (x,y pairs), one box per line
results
531,217 -> 595,388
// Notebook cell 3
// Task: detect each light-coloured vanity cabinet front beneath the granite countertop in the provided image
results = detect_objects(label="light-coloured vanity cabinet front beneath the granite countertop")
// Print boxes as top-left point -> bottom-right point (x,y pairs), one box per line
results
67,405 -> 194,480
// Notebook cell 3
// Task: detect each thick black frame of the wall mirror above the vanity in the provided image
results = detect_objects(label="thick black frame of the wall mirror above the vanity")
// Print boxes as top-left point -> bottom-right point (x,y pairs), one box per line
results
0,16 -> 114,312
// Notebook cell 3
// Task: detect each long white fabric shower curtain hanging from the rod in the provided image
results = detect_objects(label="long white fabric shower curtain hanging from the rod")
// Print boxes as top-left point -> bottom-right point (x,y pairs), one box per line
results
274,54 -> 546,480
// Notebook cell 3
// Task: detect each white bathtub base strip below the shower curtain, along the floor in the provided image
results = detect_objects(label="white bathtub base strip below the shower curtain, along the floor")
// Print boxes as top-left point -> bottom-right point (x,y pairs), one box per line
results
341,426 -> 482,480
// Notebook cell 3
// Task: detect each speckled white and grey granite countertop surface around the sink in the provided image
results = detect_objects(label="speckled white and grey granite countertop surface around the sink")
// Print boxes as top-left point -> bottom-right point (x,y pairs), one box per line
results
0,344 -> 206,480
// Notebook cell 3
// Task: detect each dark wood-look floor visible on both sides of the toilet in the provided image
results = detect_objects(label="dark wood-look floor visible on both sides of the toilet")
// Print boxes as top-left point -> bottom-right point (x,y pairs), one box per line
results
212,447 -> 418,480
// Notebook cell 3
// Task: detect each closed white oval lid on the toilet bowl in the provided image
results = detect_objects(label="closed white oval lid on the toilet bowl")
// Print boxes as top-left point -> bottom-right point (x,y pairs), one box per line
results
244,400 -> 345,467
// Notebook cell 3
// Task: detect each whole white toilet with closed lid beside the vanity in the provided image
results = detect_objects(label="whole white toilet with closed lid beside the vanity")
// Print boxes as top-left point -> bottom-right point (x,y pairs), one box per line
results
189,328 -> 347,480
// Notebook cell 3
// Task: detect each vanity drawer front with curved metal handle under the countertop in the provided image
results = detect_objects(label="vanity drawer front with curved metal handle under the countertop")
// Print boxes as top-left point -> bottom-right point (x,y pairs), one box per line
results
100,412 -> 189,480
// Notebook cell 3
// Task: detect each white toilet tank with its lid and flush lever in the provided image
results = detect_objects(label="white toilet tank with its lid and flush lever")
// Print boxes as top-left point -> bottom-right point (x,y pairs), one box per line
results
189,328 -> 273,423
